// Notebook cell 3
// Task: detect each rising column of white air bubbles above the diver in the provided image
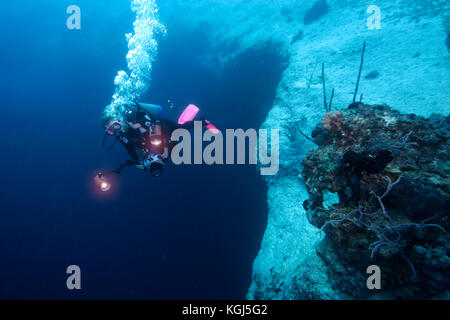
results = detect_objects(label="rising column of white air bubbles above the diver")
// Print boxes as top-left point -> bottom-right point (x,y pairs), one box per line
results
111,0 -> 166,113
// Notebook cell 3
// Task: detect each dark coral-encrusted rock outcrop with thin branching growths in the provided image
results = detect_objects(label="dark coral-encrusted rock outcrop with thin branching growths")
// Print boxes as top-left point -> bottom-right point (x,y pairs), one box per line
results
302,102 -> 450,298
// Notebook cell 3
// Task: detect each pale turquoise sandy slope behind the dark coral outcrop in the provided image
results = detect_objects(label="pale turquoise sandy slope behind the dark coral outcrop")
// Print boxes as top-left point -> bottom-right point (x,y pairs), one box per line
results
160,0 -> 450,299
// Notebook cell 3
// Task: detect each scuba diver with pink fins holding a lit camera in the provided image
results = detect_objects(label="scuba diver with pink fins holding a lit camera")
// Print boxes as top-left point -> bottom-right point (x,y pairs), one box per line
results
96,102 -> 218,180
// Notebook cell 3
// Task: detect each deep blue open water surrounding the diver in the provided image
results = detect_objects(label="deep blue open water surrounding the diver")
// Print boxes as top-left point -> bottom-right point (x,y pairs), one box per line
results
0,0 -> 283,299
